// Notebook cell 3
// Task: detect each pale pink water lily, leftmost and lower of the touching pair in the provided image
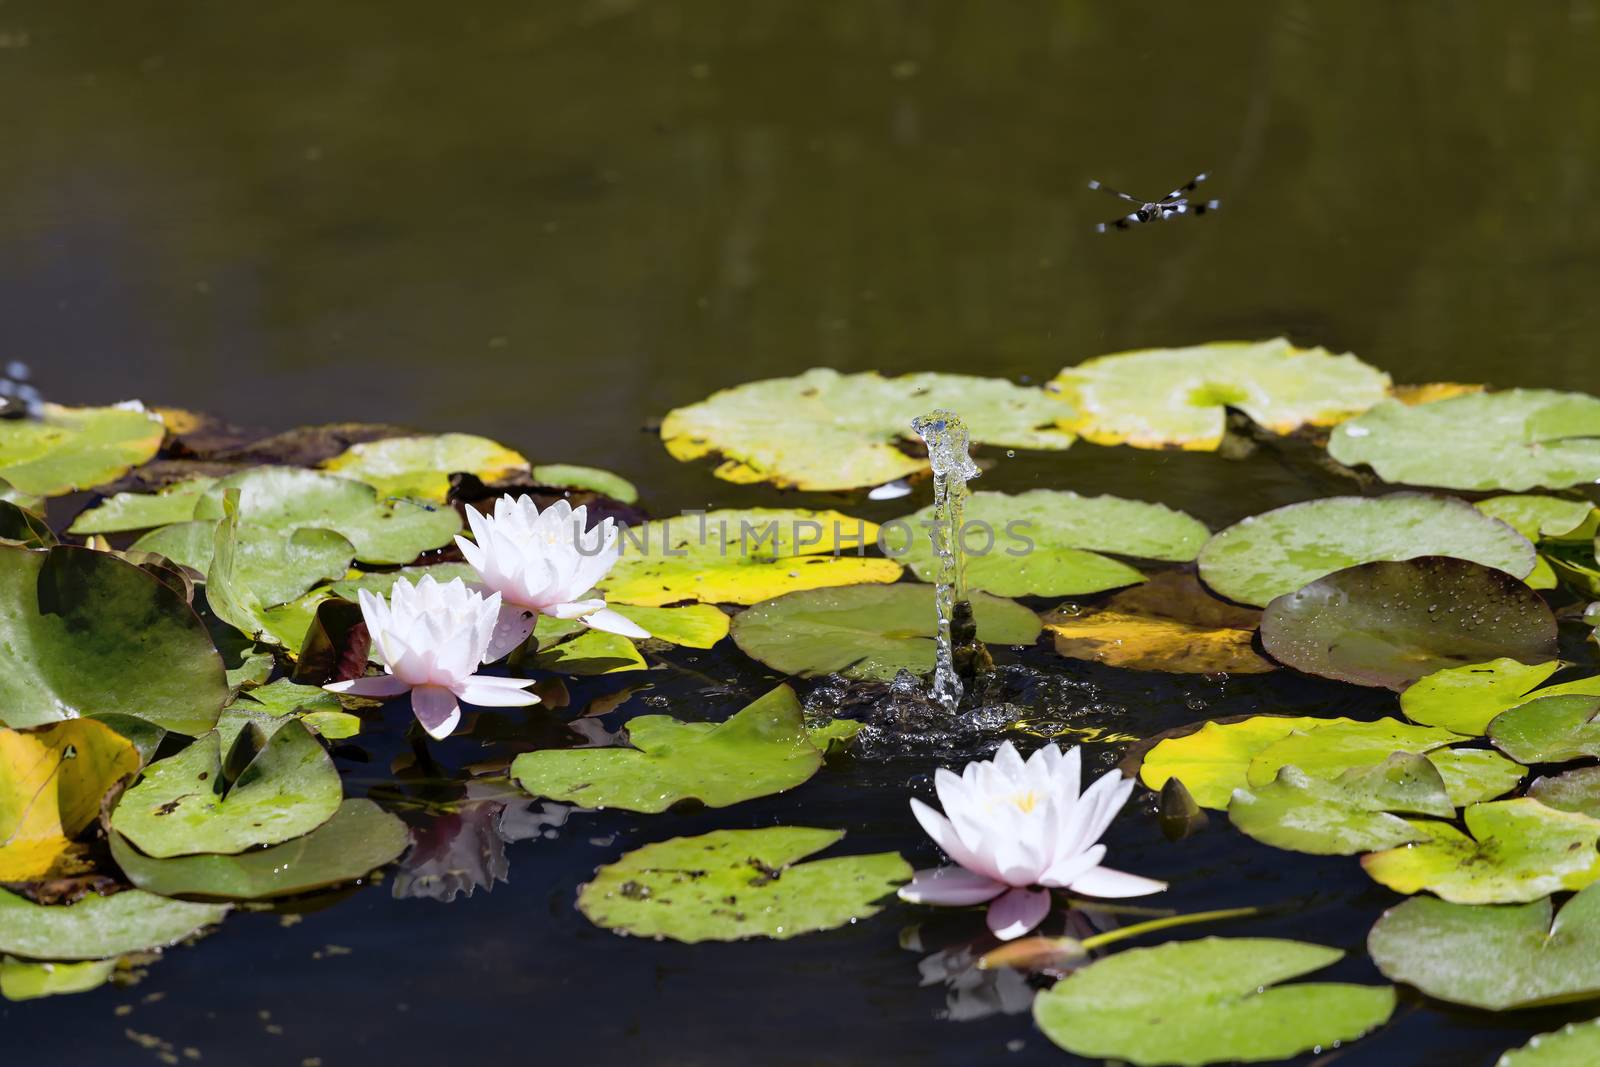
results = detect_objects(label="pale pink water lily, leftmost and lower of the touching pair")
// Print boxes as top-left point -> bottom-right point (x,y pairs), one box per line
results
323,574 -> 539,739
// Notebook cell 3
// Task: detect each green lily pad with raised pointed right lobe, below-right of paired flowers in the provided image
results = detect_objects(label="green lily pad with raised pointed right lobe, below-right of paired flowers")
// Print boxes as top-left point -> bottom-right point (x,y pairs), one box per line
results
510,685 -> 822,813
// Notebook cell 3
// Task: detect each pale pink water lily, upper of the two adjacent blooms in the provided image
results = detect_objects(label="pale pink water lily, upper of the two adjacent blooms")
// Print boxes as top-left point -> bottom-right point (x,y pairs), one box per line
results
456,496 -> 650,662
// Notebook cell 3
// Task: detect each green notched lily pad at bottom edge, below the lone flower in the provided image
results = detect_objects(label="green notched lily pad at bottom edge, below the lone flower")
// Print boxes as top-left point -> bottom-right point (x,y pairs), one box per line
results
1034,937 -> 1395,1065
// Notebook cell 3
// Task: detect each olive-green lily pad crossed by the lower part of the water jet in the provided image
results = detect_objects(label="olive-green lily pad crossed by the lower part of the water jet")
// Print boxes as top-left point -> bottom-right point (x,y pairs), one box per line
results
731,584 -> 1042,681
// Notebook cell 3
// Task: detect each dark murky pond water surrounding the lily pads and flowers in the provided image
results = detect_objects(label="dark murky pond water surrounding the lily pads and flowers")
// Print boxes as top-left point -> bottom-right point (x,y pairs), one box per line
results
0,0 -> 1600,1067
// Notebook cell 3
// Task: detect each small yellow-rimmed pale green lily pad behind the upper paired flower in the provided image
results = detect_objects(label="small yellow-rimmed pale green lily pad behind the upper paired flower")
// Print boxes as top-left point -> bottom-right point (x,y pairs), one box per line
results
322,434 -> 530,504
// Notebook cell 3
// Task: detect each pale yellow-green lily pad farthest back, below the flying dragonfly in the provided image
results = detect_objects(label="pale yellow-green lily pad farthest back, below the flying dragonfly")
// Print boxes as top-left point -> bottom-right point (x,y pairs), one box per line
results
1049,338 -> 1389,451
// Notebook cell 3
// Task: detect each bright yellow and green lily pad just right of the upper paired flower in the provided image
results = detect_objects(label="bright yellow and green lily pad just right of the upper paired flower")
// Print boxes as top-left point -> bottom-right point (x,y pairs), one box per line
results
600,507 -> 901,608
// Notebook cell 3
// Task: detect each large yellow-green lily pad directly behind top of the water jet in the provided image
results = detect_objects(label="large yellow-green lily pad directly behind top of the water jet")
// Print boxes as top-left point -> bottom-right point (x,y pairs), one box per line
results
661,368 -> 1072,490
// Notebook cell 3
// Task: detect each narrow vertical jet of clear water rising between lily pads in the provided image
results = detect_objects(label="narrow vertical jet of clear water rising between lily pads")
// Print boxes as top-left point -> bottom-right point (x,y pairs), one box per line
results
910,408 -> 982,712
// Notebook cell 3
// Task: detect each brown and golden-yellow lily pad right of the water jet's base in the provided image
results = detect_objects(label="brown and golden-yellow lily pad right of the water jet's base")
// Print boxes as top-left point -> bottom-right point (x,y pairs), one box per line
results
1045,571 -> 1277,673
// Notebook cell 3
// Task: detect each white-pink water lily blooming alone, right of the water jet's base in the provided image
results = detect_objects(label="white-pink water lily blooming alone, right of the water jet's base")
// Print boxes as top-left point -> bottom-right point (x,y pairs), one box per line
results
899,741 -> 1166,941
